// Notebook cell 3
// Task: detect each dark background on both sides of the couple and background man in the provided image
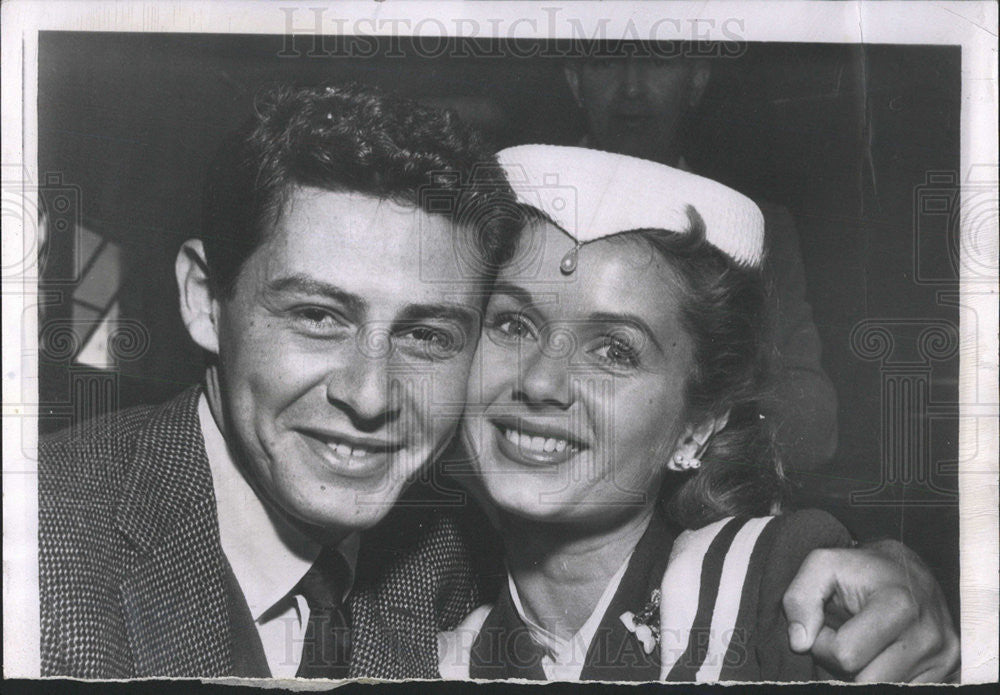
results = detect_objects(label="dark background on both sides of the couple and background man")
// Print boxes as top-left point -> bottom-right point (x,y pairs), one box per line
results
38,32 -> 961,619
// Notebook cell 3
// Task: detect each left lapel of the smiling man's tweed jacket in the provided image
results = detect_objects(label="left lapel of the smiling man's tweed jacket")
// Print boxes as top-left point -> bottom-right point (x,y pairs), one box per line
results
117,388 -> 233,676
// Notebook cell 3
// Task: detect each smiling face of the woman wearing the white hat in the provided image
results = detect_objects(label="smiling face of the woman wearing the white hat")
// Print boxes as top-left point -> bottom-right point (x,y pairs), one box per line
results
463,224 -> 694,522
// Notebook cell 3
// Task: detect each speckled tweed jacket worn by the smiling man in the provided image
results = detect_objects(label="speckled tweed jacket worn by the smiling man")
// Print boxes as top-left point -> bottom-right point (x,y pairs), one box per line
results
38,388 -> 479,679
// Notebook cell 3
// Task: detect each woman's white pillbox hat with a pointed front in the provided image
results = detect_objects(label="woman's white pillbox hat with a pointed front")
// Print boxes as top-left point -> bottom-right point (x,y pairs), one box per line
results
497,145 -> 764,267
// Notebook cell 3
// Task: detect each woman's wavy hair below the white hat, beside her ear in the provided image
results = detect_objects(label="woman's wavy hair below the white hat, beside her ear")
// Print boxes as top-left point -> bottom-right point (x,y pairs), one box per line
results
621,207 -> 787,528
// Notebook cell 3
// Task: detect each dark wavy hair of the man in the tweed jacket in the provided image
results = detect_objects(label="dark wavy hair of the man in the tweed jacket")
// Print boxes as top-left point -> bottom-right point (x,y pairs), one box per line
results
201,83 -> 521,296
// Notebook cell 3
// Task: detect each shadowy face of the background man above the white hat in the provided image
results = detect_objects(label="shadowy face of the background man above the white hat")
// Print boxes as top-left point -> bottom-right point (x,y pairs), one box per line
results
569,57 -> 707,165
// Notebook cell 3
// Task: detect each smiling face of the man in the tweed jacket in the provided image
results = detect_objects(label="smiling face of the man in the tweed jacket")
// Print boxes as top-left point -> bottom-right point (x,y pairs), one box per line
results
213,188 -> 482,530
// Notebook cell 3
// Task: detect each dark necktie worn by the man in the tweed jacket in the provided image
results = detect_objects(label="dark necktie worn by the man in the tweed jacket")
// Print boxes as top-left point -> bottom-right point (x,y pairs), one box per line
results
295,548 -> 351,678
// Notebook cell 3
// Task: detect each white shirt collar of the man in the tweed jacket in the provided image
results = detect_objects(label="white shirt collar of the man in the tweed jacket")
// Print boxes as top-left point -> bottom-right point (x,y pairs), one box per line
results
198,393 -> 360,620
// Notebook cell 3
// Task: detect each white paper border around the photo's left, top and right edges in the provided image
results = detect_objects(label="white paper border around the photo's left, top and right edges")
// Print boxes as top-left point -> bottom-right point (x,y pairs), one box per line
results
0,0 -> 1000,683
